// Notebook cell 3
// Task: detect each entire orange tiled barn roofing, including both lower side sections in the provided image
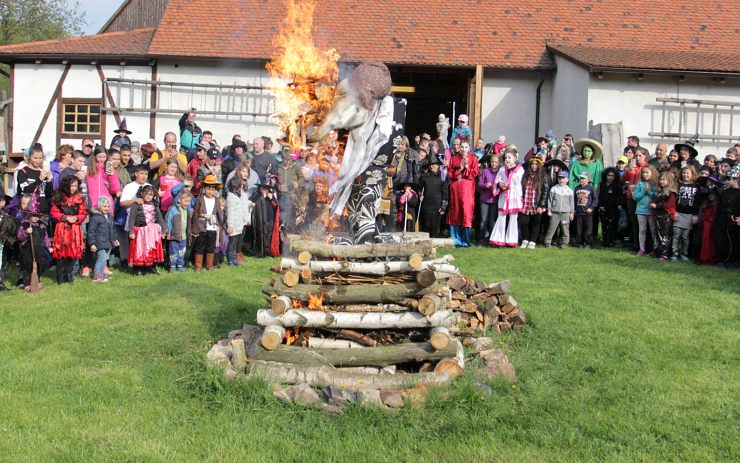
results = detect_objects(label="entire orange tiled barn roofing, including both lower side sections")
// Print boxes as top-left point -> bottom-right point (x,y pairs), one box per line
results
0,0 -> 740,72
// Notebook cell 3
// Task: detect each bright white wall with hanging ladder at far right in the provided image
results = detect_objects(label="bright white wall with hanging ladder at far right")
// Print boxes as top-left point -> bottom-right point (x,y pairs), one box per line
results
586,74 -> 740,158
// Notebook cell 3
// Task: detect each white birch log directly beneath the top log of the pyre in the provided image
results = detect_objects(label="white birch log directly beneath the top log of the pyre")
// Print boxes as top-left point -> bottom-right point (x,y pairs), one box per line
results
280,254 -> 460,275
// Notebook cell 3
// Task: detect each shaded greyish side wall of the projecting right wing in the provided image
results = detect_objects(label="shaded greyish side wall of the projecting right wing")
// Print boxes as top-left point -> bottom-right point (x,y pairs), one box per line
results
543,56 -> 588,138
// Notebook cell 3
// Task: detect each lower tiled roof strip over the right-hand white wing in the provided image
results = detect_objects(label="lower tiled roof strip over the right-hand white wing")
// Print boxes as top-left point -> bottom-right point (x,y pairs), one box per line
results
549,46 -> 740,73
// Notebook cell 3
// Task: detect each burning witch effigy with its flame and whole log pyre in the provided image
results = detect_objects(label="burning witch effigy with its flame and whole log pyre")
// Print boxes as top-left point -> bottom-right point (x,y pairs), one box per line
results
208,0 -> 526,407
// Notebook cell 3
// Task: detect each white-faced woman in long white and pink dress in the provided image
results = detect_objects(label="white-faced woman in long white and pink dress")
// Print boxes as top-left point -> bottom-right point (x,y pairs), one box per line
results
488,145 -> 524,247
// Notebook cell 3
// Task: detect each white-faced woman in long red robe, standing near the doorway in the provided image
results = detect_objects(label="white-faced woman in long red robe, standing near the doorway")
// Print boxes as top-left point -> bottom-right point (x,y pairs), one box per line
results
447,142 -> 479,248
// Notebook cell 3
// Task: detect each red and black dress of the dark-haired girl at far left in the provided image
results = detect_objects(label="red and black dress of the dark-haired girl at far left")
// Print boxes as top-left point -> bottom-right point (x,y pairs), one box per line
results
51,194 -> 87,259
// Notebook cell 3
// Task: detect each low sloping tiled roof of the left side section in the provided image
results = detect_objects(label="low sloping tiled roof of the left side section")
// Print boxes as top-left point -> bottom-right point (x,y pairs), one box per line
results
0,28 -> 154,59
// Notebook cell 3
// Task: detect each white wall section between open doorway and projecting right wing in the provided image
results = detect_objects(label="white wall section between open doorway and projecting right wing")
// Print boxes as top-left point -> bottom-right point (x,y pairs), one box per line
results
481,70 -> 552,153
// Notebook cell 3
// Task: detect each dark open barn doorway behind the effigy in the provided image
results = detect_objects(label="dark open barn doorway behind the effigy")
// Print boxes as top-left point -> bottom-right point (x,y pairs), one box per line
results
389,66 -> 473,144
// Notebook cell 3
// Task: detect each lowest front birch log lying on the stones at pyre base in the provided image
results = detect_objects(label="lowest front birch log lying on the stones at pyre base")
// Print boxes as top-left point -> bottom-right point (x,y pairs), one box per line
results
250,362 -> 453,391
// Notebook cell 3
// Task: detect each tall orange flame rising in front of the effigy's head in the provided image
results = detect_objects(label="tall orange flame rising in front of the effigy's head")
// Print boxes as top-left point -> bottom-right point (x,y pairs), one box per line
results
266,0 -> 339,149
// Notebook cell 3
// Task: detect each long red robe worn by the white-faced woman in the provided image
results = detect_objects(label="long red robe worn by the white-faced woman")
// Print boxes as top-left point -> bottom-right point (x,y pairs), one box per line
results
447,154 -> 478,228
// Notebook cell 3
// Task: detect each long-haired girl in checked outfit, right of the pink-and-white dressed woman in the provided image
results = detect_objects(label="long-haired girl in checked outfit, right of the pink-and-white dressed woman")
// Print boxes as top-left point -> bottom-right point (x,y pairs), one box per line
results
519,157 -> 547,249
